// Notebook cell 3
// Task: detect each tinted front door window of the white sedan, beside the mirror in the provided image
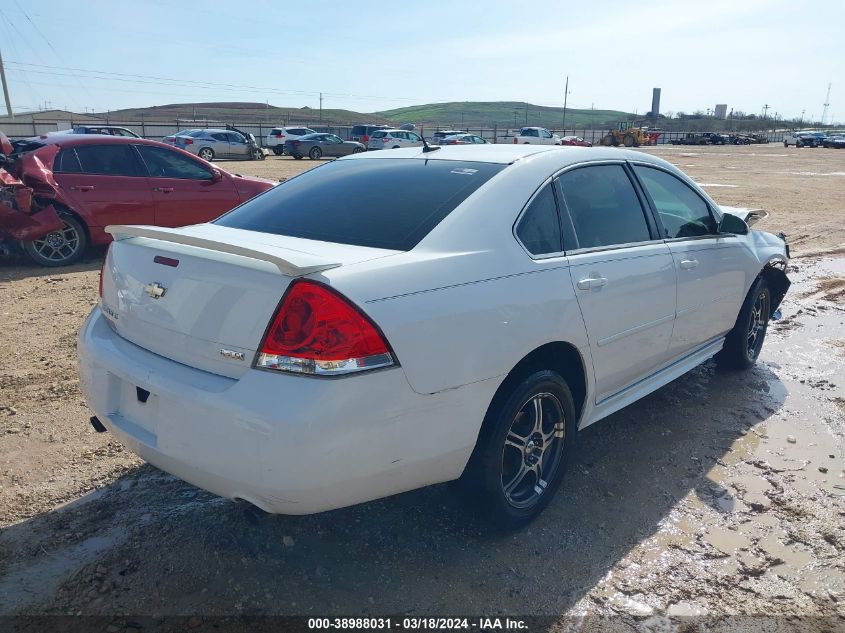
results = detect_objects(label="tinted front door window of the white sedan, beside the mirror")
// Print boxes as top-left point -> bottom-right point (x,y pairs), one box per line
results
634,165 -> 716,239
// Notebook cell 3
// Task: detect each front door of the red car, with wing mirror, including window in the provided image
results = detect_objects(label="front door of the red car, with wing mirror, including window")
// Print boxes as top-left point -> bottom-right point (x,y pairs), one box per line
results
134,144 -> 240,226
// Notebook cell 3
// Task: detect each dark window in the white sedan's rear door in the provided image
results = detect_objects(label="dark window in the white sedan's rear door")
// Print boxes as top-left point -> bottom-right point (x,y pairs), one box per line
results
558,165 -> 651,248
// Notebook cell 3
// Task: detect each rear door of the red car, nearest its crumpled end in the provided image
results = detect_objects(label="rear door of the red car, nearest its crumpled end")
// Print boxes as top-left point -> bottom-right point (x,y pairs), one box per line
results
55,143 -> 155,227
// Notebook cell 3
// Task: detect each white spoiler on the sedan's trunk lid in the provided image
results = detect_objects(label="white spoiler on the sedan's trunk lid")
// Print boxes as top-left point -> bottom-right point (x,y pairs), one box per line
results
105,224 -> 341,277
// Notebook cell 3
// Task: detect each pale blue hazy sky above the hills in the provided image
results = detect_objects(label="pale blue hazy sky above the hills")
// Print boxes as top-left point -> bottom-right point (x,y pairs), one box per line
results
0,0 -> 845,120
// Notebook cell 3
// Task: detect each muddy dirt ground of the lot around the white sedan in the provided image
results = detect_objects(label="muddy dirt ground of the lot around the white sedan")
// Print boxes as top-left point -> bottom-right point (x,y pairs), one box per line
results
0,145 -> 845,631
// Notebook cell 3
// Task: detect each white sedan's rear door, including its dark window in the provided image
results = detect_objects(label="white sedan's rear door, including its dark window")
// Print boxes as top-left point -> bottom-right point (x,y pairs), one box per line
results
557,163 -> 675,403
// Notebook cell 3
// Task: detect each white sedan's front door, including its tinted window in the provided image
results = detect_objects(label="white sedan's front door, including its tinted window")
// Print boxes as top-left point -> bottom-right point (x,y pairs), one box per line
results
634,165 -> 748,356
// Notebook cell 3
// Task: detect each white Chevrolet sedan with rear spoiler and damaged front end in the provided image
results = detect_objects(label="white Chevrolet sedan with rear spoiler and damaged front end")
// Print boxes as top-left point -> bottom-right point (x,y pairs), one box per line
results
78,145 -> 789,527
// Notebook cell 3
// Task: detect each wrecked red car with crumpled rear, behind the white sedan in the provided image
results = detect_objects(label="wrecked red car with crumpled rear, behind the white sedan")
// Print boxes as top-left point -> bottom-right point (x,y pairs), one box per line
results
0,132 -> 274,266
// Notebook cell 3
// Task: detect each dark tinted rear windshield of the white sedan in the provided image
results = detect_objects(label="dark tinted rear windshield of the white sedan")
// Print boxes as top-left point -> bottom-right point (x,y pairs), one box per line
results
215,159 -> 505,251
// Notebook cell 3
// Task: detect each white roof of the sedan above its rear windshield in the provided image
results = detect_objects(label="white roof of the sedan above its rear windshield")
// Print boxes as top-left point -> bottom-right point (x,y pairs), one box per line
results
338,143 -> 669,167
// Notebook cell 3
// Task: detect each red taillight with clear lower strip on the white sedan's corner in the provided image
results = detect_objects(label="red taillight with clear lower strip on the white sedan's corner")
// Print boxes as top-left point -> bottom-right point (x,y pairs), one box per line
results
255,280 -> 394,376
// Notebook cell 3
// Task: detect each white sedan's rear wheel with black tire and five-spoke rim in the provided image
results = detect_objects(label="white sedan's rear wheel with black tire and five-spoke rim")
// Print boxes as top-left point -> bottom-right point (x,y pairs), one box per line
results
461,370 -> 577,529
